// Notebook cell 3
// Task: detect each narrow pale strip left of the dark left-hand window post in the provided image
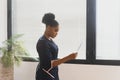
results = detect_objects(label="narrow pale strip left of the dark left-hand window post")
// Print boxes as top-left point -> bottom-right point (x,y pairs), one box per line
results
0,0 -> 7,56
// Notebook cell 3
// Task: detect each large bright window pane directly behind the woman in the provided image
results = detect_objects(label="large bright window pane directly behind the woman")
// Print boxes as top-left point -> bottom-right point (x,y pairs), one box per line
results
12,0 -> 86,59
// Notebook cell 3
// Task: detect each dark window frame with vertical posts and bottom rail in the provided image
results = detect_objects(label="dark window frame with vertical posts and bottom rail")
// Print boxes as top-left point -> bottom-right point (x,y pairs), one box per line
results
7,0 -> 120,66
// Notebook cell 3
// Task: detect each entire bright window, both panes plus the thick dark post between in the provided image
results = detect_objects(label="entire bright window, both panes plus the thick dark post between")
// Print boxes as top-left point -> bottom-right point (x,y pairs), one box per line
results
8,0 -> 120,65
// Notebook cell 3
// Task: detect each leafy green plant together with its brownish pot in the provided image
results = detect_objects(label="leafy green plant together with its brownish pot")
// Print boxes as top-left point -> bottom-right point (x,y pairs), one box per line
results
0,34 -> 28,80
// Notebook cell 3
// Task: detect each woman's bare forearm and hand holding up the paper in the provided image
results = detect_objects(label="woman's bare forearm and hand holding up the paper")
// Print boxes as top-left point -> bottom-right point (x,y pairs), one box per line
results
51,53 -> 77,67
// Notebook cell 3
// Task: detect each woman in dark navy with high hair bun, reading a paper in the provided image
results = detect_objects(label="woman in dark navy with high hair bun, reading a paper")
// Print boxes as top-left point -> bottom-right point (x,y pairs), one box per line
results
36,13 -> 77,80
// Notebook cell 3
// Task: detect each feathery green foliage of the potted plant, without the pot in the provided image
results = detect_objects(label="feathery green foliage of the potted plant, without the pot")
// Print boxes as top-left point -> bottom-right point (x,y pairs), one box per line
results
0,34 -> 29,67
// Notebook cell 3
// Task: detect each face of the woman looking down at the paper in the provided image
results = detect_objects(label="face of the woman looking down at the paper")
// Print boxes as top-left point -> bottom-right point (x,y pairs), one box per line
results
47,26 -> 59,38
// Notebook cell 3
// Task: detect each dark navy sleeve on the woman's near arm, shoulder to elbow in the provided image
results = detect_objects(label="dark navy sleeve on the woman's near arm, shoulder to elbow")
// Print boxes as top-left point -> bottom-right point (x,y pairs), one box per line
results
37,40 -> 52,70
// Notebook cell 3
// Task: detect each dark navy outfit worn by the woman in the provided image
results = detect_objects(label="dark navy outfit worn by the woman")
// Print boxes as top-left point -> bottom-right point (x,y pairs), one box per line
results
36,36 -> 59,80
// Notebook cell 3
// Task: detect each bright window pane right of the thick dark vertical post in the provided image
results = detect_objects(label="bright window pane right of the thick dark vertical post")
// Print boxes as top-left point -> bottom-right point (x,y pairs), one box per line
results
96,0 -> 120,60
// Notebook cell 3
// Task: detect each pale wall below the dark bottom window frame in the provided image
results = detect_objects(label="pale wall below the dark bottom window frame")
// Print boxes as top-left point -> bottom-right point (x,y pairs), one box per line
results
14,62 -> 120,80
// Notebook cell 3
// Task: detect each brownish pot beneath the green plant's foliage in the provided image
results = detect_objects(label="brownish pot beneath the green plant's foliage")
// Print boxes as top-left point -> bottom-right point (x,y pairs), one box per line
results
0,59 -> 14,80
